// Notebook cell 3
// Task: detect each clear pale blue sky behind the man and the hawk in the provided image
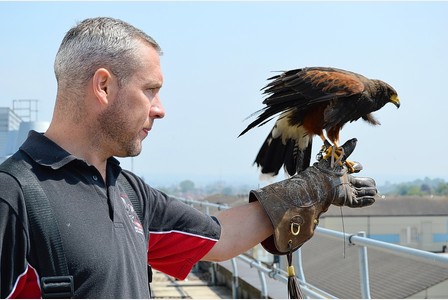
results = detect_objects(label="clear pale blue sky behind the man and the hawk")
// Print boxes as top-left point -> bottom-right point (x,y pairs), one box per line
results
0,1 -> 448,186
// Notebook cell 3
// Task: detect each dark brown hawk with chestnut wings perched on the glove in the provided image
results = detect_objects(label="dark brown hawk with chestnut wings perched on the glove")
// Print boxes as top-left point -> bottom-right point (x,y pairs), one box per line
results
239,67 -> 400,176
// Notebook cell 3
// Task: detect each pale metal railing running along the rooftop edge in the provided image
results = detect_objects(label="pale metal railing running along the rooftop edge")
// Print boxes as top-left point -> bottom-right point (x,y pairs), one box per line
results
178,198 -> 448,299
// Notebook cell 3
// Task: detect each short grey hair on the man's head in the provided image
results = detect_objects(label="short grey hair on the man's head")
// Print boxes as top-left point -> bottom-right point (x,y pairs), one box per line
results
54,17 -> 162,88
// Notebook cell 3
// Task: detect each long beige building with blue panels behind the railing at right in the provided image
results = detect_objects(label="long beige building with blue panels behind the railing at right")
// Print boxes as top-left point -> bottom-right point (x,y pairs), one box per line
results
319,196 -> 448,252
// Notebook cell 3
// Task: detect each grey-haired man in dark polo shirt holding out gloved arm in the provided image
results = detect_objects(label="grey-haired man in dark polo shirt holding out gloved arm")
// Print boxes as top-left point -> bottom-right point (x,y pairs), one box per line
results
0,18 -> 376,298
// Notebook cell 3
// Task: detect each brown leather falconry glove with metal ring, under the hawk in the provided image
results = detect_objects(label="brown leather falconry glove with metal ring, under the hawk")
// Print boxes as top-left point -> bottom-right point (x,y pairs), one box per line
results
249,138 -> 377,255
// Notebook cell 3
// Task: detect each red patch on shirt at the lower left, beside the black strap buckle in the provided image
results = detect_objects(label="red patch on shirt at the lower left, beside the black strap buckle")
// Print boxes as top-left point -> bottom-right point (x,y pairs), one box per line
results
7,265 -> 41,299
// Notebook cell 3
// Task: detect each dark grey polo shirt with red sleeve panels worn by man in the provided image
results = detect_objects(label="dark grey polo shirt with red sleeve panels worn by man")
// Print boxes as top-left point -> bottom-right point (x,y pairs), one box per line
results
0,131 -> 221,298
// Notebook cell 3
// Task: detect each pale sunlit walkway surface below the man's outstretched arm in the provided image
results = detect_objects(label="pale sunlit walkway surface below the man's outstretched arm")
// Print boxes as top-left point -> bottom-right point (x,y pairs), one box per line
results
151,270 -> 232,299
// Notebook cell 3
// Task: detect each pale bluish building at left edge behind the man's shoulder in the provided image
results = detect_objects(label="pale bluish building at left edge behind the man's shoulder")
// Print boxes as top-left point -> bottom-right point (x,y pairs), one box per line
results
0,100 -> 49,163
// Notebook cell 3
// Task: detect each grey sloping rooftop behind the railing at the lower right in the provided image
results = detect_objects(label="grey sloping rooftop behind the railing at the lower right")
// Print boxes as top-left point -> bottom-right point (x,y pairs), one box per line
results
302,235 -> 448,299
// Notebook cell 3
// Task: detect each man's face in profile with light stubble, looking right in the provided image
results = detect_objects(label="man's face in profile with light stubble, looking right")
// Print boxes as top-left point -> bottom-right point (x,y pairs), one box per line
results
99,44 -> 165,157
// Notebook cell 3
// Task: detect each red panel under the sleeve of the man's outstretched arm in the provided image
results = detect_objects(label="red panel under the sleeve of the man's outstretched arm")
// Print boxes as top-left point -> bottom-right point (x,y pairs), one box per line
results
148,231 -> 217,279
